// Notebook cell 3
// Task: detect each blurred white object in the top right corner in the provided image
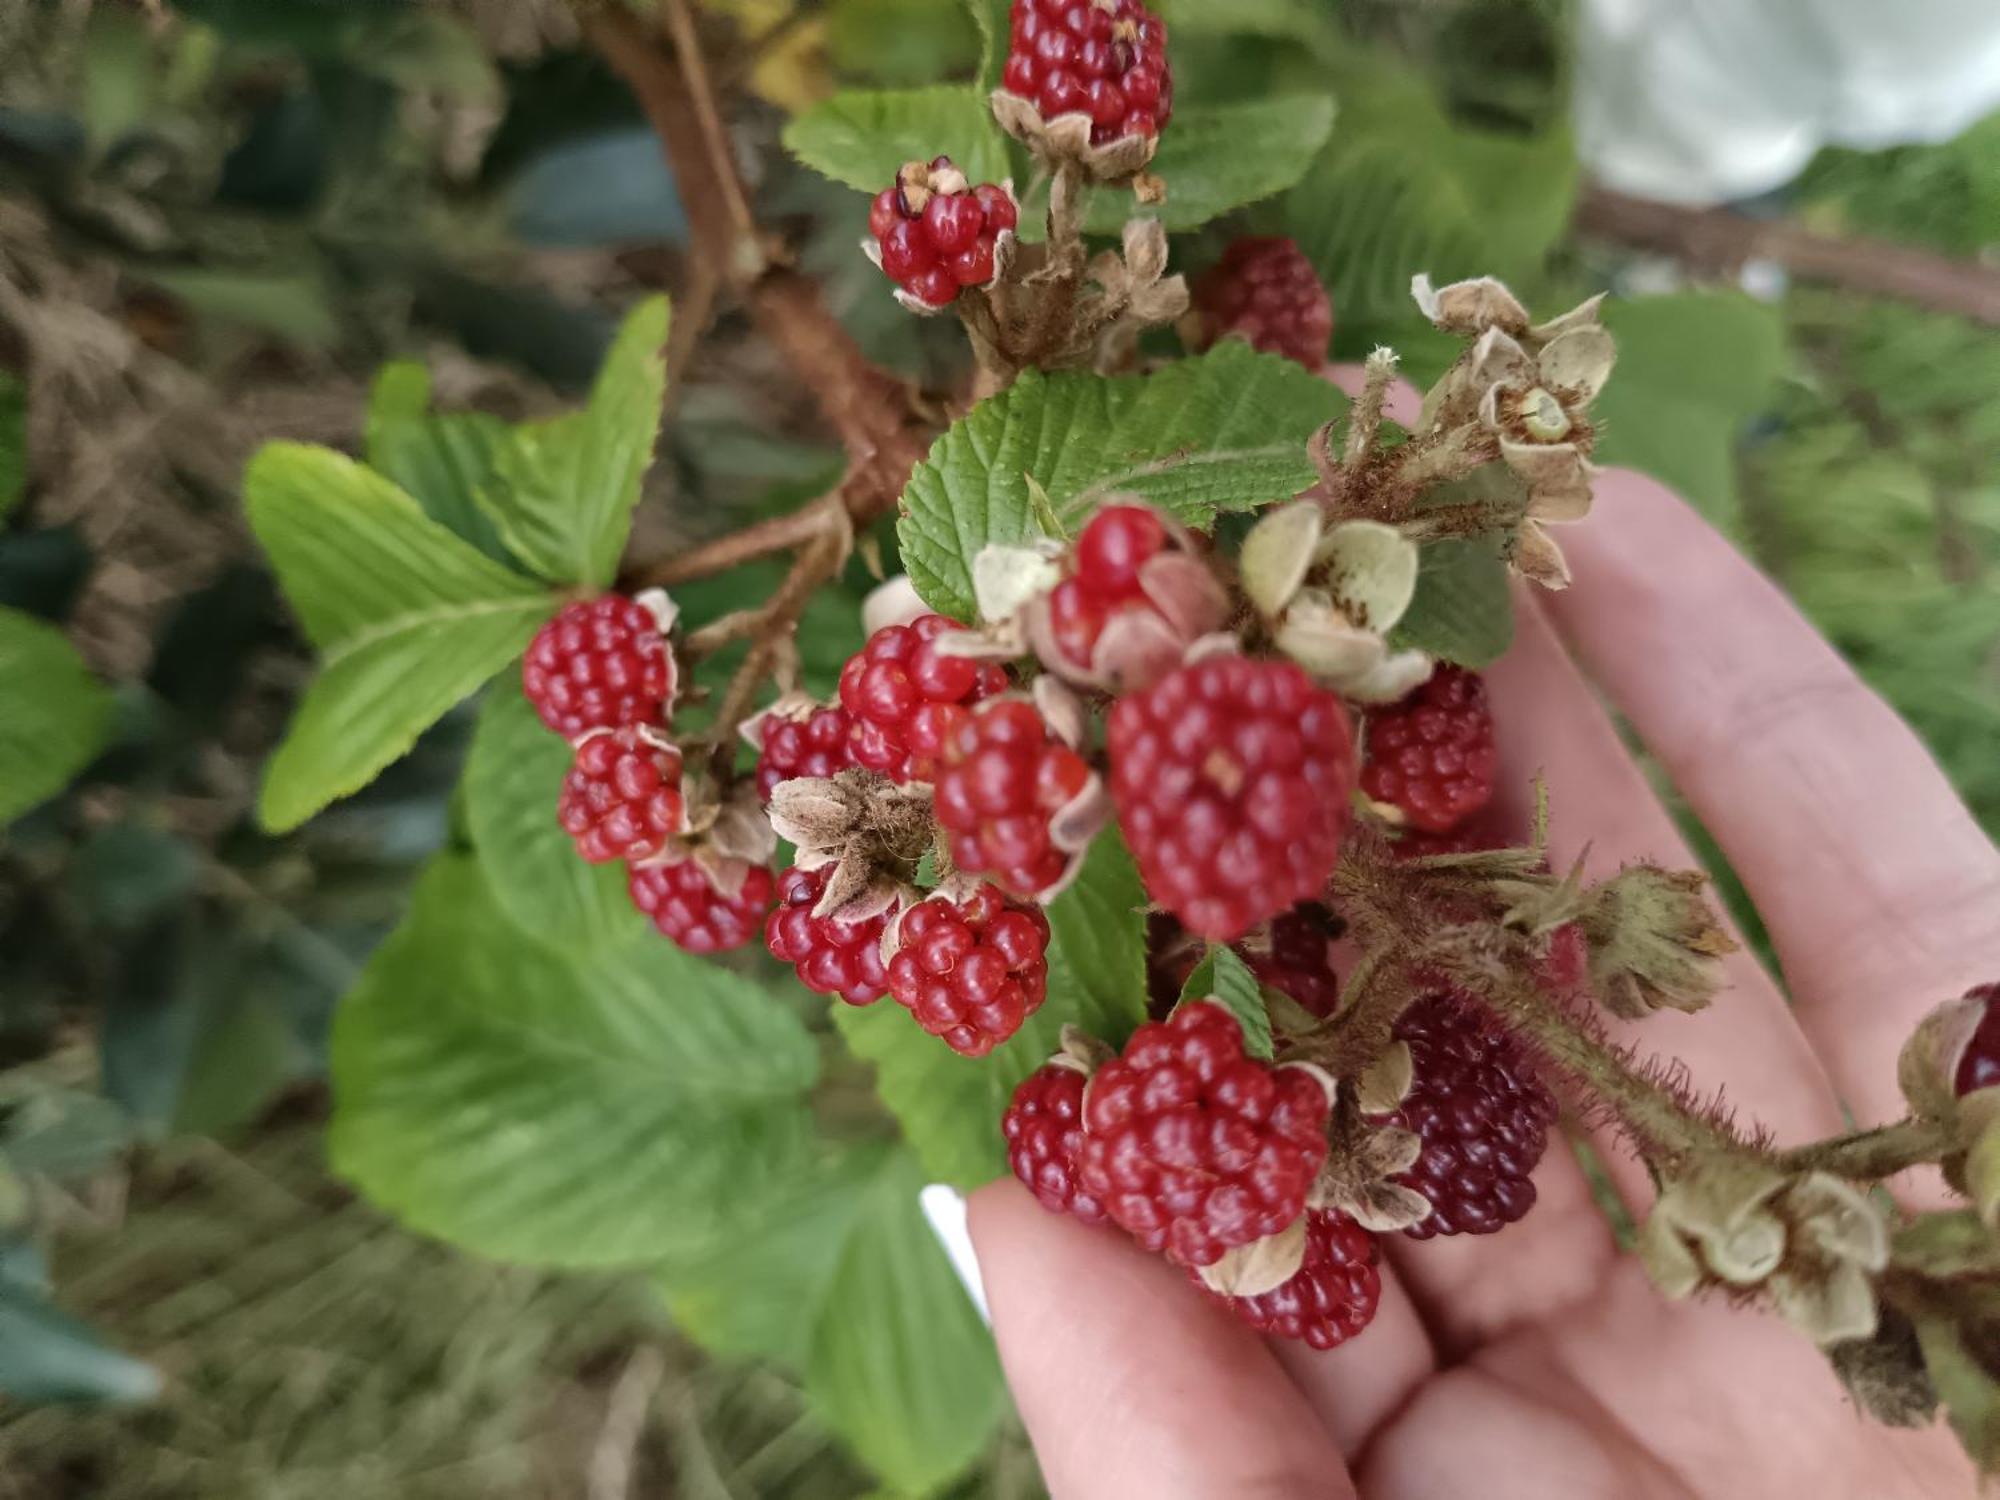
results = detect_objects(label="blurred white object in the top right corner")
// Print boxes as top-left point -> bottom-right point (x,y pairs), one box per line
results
1576,0 -> 2000,204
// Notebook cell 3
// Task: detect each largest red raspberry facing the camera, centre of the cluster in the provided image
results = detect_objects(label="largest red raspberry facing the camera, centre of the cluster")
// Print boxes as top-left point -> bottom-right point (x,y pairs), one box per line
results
1110,656 -> 1354,942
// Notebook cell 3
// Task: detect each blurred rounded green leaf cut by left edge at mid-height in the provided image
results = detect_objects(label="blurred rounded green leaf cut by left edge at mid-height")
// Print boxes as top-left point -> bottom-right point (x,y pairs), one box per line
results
0,610 -> 112,824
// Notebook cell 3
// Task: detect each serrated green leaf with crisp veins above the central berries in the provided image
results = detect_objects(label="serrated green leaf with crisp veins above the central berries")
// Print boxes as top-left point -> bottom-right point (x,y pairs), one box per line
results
896,340 -> 1346,620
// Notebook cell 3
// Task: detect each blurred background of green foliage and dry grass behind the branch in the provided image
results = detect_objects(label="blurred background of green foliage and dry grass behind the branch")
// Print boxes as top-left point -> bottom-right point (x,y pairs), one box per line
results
0,0 -> 2000,1500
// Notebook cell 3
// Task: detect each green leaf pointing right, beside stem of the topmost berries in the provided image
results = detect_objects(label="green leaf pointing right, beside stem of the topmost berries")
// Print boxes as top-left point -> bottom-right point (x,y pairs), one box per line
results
1086,94 -> 1334,234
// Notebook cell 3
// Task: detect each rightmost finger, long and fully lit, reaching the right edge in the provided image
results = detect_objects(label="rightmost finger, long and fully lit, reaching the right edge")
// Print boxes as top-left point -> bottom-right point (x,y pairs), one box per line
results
1548,470 -> 2000,1124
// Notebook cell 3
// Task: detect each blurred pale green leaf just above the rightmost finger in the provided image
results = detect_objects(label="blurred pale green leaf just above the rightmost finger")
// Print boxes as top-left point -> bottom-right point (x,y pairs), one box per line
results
1592,292 -> 1786,540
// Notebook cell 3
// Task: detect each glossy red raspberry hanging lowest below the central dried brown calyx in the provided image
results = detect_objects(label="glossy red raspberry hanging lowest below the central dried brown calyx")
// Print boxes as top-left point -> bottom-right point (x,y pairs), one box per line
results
888,884 -> 1048,1058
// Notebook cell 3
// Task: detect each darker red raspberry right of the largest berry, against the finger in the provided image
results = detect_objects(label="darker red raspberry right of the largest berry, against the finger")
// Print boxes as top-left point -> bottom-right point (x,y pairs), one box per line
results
1362,662 -> 1500,834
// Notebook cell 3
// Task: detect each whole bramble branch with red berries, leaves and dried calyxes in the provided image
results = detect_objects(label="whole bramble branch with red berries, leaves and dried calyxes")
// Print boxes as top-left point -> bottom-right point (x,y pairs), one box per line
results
238,0 -> 2000,1488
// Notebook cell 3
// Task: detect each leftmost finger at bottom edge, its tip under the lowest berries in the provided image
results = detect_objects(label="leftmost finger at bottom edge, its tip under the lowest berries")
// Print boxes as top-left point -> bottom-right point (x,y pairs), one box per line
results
970,1182 -> 1428,1500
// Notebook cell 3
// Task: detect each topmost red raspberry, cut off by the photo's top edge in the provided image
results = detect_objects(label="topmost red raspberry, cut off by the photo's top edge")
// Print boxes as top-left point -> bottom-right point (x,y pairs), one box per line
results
1000,0 -> 1174,146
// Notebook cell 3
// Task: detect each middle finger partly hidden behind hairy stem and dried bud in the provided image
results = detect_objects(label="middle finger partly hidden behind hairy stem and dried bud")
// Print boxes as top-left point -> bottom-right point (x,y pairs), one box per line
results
1486,600 -> 1840,1204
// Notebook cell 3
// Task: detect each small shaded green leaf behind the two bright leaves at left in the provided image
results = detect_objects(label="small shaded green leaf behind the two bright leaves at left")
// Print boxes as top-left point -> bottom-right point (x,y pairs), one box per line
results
366,360 -> 514,562
